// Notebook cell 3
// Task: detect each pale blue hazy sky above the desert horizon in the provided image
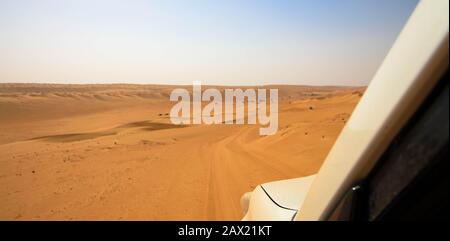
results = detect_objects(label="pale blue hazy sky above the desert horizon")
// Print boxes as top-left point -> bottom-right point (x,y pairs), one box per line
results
0,0 -> 417,85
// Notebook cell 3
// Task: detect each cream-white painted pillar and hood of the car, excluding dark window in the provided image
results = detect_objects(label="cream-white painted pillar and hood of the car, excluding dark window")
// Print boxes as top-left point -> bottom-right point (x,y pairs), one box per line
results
241,0 -> 449,220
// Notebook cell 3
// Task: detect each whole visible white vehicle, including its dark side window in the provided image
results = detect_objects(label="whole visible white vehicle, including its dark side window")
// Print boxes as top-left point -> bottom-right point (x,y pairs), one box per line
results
241,0 -> 449,220
